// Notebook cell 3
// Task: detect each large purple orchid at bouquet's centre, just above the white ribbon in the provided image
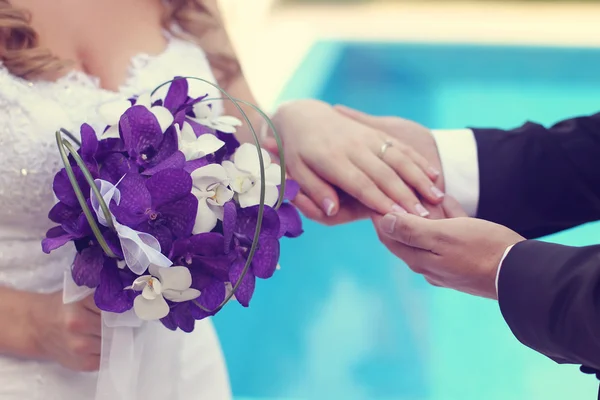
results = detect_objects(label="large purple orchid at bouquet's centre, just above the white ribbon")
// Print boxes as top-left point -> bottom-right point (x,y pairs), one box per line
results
111,169 -> 198,254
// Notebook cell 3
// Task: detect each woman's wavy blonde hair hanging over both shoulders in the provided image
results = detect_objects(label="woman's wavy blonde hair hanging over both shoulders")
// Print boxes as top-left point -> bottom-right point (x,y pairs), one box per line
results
0,0 -> 241,86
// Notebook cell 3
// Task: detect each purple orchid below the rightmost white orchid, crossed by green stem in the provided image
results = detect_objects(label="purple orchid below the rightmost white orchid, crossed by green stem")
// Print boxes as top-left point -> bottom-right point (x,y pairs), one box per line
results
223,203 -> 281,307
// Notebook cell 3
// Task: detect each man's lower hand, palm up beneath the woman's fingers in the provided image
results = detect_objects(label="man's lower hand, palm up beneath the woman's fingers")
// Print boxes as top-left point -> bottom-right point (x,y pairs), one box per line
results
373,209 -> 525,299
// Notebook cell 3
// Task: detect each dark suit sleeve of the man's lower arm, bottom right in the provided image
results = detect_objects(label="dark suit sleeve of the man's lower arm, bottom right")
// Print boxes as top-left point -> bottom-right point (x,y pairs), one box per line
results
498,240 -> 600,370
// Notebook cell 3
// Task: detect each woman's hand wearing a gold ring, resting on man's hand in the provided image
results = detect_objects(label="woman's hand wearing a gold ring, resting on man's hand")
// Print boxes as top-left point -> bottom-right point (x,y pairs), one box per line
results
263,100 -> 443,223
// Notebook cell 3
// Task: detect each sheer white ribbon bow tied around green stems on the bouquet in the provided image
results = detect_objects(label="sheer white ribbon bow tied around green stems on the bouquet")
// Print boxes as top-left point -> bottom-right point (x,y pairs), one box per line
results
90,179 -> 173,275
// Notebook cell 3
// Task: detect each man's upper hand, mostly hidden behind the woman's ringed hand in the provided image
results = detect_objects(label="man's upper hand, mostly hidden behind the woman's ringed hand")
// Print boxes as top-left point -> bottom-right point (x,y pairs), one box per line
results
334,105 -> 445,192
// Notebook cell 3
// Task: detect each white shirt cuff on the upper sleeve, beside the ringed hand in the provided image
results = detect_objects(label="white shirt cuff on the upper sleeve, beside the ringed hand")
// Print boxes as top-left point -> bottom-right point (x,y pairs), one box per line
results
431,129 -> 479,217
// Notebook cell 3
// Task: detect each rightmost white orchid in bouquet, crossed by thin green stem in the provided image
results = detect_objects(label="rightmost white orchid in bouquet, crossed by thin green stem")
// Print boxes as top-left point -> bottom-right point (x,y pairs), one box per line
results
223,143 -> 281,208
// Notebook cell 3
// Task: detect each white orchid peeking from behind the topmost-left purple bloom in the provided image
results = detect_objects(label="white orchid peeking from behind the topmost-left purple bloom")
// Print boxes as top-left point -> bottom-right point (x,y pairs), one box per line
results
98,93 -> 173,139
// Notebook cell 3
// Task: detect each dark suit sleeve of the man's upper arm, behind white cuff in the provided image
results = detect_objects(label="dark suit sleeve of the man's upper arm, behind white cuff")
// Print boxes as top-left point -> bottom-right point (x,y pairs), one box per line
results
473,114 -> 600,238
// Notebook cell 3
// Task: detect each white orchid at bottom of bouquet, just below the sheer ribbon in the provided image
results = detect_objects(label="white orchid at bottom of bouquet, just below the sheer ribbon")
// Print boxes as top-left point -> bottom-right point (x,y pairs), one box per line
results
128,265 -> 200,321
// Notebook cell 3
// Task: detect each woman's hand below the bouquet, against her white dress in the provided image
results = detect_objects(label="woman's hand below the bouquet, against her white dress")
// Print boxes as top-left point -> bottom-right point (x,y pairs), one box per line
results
32,292 -> 102,371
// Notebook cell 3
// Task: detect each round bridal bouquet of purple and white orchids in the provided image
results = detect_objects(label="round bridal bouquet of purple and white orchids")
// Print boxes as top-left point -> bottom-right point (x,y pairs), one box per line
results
42,78 -> 302,332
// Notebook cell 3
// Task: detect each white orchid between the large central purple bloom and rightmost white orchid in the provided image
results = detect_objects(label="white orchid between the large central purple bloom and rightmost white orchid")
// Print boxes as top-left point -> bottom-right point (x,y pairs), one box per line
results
192,164 -> 233,234
